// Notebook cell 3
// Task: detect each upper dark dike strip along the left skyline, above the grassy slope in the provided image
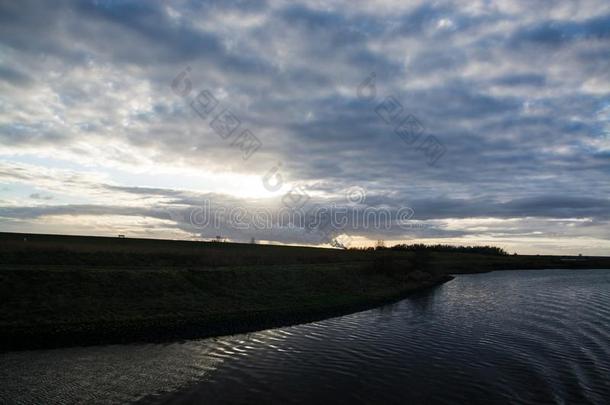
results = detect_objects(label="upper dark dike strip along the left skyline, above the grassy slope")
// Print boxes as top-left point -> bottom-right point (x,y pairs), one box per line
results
0,233 -> 370,266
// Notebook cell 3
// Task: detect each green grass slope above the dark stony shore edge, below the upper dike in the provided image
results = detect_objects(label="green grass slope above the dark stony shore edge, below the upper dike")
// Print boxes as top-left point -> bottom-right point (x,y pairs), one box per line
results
0,263 -> 428,326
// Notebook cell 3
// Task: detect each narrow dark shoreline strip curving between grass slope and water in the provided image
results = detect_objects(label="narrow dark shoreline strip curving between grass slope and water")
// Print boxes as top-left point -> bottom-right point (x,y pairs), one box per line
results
0,274 -> 448,352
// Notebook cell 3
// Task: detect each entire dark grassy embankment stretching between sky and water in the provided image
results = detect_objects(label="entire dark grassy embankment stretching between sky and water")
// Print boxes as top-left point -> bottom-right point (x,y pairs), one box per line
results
0,233 -> 610,349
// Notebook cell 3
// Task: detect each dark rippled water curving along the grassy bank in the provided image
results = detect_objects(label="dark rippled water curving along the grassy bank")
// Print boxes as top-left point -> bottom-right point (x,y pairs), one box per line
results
0,270 -> 610,404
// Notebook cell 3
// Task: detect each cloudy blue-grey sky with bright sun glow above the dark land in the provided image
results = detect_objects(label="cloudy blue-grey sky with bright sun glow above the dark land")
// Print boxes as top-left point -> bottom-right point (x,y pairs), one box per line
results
0,0 -> 610,255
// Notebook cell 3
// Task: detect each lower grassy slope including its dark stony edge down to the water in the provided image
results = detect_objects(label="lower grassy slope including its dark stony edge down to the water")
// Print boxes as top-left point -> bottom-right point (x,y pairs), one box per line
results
0,262 -> 440,349
